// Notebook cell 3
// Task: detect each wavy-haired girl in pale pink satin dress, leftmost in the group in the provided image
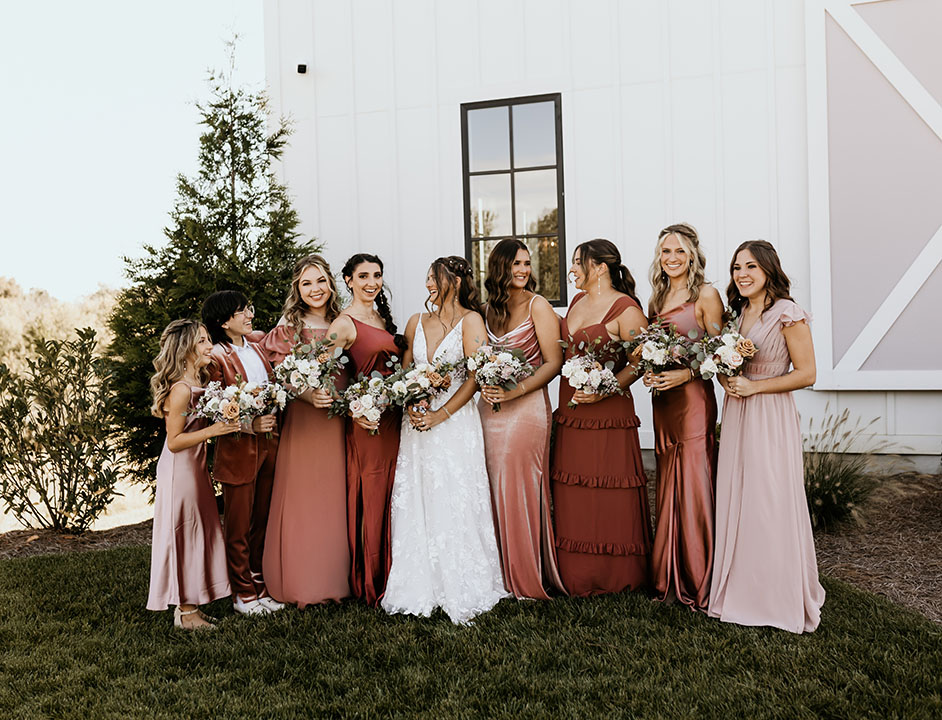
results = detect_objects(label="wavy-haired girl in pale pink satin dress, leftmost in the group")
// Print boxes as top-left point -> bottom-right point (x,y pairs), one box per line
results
147,320 -> 239,630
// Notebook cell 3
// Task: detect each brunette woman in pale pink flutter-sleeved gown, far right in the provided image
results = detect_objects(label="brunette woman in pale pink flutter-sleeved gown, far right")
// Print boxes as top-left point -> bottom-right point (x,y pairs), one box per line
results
709,240 -> 824,633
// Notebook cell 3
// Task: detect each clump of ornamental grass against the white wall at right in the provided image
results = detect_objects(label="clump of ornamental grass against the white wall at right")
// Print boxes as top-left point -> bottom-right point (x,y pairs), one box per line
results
804,407 -> 889,531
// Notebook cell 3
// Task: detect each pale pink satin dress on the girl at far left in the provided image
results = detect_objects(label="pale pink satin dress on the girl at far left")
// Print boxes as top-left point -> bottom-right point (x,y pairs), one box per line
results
147,383 -> 232,610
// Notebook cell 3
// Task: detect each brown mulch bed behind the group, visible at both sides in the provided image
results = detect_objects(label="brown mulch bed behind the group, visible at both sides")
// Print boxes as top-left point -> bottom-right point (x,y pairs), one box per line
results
0,473 -> 942,623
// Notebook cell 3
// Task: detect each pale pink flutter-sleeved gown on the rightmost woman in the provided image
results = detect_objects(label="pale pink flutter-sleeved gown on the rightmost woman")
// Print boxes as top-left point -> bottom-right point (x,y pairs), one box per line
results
709,299 -> 824,633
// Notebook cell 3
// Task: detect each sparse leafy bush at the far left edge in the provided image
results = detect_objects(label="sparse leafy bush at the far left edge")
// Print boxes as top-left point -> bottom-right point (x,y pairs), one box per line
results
0,328 -> 127,531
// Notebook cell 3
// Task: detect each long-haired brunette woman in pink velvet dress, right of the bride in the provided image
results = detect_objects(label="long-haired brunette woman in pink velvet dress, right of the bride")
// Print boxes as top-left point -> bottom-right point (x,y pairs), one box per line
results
478,239 -> 565,600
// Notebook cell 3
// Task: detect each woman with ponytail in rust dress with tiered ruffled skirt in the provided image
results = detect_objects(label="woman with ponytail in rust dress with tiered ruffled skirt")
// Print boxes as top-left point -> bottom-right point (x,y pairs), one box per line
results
551,239 -> 651,596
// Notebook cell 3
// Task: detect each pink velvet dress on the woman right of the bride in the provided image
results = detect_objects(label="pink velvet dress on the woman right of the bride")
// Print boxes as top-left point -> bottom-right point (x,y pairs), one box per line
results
478,300 -> 566,600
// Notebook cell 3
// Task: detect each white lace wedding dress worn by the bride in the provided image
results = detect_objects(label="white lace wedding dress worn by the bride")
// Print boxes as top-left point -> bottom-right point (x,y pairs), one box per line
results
382,318 -> 507,624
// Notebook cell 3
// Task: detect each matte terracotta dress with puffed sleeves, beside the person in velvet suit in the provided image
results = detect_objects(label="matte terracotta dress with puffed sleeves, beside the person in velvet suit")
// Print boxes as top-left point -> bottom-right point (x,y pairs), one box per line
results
259,325 -> 350,608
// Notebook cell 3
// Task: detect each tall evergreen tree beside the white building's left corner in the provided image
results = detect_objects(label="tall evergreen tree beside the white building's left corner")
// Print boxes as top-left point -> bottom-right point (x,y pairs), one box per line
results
108,49 -> 319,481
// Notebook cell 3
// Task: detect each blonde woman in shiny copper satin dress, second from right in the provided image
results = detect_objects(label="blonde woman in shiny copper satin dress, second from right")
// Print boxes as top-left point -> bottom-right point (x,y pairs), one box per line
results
644,223 -> 723,612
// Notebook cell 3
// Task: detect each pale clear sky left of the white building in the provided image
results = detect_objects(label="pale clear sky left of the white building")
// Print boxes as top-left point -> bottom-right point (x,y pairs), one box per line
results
0,0 -> 265,300
